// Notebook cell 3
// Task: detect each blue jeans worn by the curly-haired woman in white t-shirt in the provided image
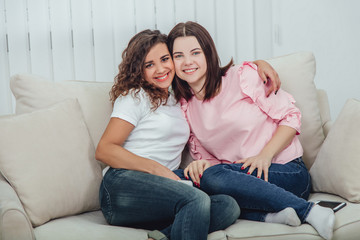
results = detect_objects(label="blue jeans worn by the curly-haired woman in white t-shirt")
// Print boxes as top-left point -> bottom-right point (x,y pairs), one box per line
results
99,168 -> 240,240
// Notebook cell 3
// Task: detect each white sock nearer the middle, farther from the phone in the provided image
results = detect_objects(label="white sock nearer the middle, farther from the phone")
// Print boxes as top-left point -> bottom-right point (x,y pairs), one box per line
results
265,207 -> 301,227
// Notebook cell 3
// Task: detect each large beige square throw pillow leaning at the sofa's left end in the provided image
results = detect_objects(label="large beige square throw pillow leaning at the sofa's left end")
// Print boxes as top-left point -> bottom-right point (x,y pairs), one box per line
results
0,99 -> 102,226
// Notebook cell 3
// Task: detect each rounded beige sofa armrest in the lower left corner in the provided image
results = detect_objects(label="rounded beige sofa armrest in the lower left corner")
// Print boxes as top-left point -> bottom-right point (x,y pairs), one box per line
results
0,173 -> 35,240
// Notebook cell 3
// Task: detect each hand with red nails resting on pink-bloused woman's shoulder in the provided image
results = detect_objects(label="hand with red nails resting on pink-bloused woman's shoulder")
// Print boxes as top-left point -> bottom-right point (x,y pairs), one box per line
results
254,60 -> 281,96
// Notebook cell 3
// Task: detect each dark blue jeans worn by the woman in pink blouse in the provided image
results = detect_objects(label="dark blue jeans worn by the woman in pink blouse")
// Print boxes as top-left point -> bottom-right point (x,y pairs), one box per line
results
200,158 -> 313,222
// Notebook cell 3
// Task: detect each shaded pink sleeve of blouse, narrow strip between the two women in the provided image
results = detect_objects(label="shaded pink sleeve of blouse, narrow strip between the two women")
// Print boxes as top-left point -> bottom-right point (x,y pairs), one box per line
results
180,99 -> 221,165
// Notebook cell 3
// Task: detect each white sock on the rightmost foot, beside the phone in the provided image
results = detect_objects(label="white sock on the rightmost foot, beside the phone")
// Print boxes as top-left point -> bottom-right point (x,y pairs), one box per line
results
305,205 -> 335,239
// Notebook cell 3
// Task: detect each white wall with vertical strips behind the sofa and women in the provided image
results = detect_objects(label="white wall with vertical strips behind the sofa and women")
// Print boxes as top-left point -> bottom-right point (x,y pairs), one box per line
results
0,0 -> 360,119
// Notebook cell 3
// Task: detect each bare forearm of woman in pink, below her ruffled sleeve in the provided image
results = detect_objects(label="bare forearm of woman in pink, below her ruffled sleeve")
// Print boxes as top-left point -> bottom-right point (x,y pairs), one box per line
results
261,125 -> 296,159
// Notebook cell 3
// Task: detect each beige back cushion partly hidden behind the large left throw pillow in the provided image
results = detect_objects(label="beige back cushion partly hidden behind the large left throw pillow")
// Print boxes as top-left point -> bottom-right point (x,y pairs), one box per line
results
10,74 -> 113,146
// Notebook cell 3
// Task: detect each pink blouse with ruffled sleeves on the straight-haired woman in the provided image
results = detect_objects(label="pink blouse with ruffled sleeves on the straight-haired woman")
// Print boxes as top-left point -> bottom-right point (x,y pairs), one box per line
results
181,62 -> 303,164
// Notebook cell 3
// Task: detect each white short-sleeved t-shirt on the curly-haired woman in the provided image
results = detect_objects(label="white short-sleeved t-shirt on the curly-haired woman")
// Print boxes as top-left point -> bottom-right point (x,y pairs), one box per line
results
111,89 -> 190,170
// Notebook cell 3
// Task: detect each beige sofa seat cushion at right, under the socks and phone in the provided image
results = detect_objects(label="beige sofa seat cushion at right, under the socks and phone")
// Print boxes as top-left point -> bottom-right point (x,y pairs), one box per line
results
225,193 -> 360,240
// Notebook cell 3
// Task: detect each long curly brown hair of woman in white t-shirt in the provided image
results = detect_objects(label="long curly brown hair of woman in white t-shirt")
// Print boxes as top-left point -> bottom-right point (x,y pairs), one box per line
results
110,29 -> 168,110
